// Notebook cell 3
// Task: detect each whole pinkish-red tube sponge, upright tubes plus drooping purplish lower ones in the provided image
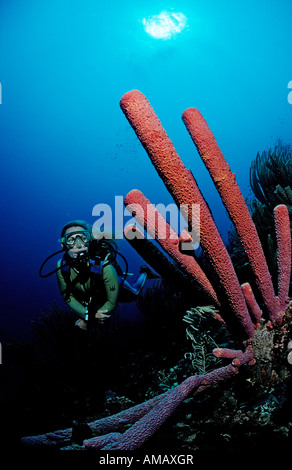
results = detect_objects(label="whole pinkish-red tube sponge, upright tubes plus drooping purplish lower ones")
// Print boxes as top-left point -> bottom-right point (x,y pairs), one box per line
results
23,90 -> 291,450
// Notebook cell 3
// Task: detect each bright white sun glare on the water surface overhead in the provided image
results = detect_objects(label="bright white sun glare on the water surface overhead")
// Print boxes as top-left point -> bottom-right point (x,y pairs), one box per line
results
143,11 -> 187,39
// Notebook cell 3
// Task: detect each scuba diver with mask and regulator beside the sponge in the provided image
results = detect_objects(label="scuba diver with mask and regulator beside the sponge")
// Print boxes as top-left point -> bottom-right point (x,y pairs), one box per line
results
51,220 -> 159,330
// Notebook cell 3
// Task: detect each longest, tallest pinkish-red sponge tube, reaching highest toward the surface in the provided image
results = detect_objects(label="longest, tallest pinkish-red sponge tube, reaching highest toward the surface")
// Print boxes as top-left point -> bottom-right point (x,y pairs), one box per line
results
120,90 -> 254,338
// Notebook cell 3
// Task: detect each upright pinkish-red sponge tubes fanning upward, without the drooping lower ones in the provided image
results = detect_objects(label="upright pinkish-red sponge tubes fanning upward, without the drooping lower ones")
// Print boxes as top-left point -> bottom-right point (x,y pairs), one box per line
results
121,90 -> 291,339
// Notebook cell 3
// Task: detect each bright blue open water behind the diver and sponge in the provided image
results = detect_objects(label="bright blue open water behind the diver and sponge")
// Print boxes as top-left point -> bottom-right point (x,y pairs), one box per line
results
0,0 -> 292,337
